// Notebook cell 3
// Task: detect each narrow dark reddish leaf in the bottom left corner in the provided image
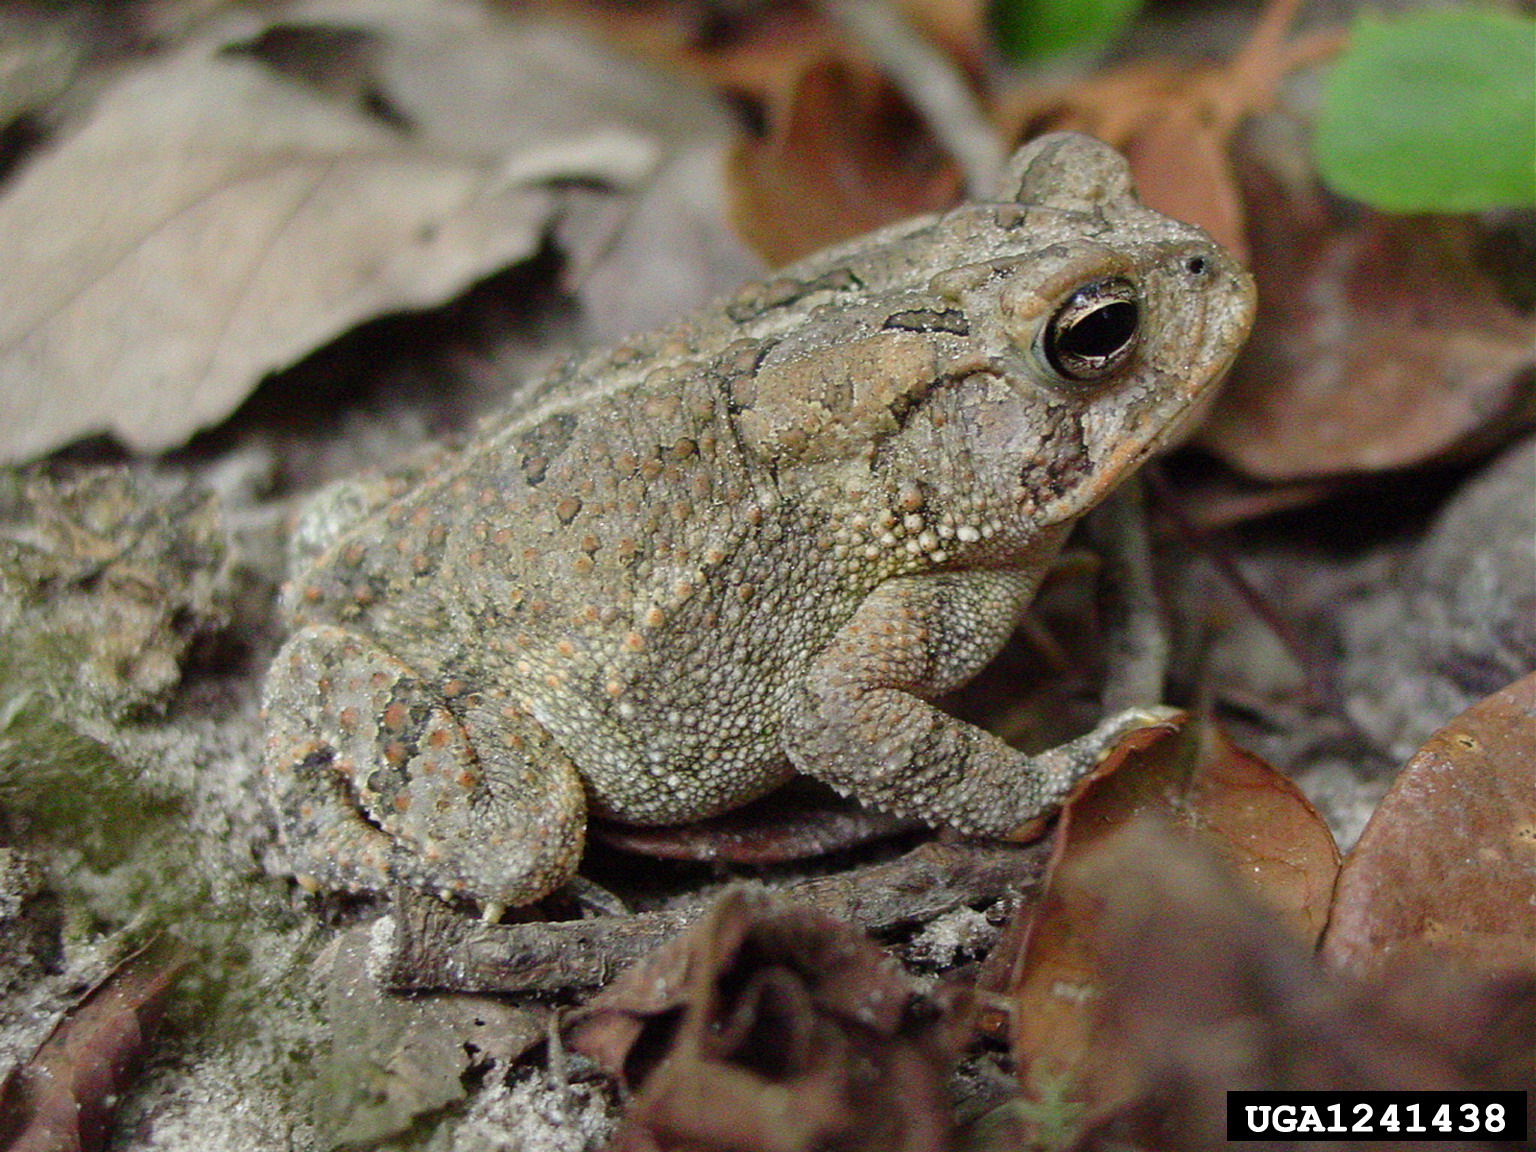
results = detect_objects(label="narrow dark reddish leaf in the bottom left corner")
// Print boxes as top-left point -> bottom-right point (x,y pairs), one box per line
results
0,946 -> 184,1152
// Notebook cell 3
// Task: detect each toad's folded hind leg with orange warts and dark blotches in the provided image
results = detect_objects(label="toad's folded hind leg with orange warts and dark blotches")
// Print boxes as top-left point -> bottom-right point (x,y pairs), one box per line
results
263,625 -> 587,906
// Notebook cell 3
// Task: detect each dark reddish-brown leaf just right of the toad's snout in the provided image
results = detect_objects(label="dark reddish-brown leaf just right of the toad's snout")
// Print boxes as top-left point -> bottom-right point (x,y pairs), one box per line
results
1198,170 -> 1536,481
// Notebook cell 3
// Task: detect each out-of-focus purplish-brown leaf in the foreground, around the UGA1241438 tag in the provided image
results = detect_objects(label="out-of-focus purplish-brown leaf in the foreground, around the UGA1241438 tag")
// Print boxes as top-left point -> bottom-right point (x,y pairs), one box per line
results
1066,820 -> 1536,1152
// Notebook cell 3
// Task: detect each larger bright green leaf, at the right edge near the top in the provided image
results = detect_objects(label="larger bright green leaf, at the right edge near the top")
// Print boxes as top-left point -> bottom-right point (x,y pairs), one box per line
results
1312,9 -> 1536,212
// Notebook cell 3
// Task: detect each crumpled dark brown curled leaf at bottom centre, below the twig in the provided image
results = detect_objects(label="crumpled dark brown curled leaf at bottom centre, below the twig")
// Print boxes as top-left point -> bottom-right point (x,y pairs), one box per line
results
570,886 -> 955,1152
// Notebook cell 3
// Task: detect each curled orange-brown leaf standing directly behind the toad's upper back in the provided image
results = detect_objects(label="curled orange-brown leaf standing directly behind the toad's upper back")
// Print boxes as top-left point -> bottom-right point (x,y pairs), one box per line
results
728,55 -> 962,264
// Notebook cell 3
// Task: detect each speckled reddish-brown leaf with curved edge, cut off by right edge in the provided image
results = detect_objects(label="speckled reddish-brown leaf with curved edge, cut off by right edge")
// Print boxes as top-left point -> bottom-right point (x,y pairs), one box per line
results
1322,673 -> 1536,972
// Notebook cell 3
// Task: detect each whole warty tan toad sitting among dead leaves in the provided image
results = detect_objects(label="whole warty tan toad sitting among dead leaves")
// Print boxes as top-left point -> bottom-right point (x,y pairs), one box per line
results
264,134 -> 1253,905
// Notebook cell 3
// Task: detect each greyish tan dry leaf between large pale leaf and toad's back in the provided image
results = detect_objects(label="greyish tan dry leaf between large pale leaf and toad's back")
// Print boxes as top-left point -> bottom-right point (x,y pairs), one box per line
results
290,0 -> 740,344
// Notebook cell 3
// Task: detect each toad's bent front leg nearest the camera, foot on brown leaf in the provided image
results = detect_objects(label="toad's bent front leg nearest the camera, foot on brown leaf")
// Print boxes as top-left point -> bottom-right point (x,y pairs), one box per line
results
785,570 -> 1172,836
